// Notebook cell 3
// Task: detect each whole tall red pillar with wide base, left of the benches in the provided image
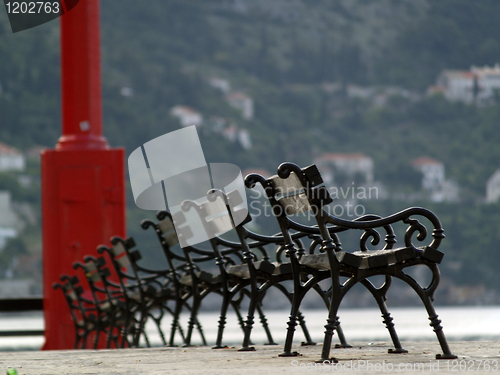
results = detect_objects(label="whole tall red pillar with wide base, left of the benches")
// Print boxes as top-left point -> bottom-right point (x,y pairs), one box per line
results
42,0 -> 125,349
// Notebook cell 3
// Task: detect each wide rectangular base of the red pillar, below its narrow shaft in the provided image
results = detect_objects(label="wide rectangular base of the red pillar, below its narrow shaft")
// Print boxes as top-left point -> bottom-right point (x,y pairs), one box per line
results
42,149 -> 126,350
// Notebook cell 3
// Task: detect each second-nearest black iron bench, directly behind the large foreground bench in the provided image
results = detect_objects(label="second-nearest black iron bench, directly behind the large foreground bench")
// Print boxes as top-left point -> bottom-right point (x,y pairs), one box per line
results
179,191 -> 349,351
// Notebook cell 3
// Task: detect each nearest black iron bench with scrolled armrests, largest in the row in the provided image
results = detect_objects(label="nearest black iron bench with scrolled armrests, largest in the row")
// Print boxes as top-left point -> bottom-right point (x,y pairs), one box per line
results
246,163 -> 456,360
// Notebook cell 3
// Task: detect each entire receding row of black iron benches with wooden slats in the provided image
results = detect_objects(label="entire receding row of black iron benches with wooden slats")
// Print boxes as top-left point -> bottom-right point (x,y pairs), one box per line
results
55,163 -> 456,361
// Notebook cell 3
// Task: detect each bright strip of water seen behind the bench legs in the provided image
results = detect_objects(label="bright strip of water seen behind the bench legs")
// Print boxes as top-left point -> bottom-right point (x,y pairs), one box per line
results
0,306 -> 500,350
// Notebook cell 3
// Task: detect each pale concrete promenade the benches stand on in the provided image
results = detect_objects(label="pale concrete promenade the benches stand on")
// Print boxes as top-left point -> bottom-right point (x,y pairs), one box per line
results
0,341 -> 500,375
